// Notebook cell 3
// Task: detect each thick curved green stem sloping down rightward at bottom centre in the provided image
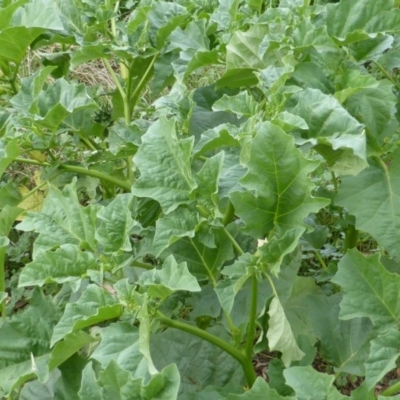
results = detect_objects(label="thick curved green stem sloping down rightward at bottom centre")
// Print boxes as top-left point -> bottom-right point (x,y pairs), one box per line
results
157,311 -> 256,387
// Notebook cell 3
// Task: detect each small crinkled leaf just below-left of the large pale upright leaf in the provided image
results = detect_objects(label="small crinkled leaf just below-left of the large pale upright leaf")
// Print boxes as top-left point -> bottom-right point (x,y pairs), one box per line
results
96,194 -> 140,253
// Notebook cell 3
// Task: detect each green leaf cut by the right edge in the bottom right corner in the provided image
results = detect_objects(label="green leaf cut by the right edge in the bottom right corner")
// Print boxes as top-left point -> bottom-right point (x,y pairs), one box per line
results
365,326 -> 400,390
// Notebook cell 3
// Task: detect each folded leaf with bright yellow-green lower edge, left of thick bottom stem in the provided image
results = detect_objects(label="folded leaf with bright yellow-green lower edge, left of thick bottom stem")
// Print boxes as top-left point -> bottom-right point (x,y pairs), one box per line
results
51,285 -> 122,345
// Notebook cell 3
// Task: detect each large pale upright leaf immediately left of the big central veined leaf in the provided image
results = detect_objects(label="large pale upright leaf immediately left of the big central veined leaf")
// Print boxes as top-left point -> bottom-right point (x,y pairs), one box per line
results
133,118 -> 197,214
